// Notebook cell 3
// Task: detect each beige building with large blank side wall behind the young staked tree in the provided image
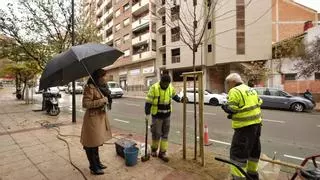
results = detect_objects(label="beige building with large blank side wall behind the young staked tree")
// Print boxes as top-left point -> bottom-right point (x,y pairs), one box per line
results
156,0 -> 272,92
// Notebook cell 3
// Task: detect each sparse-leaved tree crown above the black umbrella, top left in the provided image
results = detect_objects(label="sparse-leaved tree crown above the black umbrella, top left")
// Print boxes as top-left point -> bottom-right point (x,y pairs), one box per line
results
0,0 -> 99,69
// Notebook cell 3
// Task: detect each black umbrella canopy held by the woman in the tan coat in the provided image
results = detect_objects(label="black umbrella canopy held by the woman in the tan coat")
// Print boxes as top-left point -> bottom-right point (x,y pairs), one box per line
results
39,43 -> 123,90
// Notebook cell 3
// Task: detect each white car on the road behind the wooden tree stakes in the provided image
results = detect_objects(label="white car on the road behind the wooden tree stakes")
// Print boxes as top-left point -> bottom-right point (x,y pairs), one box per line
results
178,88 -> 227,106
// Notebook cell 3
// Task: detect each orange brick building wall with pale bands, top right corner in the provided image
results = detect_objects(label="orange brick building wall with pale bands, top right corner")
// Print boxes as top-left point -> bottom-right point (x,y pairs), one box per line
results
272,0 -> 319,42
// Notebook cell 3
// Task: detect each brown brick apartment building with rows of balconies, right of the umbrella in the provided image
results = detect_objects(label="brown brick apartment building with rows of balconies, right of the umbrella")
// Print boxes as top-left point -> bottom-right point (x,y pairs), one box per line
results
89,0 -> 156,91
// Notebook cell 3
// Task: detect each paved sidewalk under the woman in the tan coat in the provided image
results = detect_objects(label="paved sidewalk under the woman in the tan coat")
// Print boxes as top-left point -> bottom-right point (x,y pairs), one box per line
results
0,88 -> 228,180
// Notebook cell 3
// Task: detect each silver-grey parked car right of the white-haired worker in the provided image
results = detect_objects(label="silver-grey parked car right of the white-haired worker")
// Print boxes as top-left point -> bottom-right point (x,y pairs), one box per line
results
254,87 -> 314,112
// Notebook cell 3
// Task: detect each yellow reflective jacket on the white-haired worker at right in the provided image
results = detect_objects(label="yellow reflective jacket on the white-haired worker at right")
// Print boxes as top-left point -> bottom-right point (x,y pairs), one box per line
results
227,84 -> 262,129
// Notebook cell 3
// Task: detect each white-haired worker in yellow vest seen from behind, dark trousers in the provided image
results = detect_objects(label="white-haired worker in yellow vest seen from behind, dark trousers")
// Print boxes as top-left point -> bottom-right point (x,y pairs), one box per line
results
222,73 -> 262,180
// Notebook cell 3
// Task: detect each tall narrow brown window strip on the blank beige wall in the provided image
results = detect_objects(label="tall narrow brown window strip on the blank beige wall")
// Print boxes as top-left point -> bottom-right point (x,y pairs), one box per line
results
236,0 -> 245,54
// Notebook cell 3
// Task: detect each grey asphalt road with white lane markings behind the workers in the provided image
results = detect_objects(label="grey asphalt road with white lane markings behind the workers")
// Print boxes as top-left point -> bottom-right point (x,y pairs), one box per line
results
36,93 -> 320,163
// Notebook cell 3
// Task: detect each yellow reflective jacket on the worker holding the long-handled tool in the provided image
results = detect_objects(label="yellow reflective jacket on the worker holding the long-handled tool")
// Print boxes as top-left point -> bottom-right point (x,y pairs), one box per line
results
146,82 -> 176,116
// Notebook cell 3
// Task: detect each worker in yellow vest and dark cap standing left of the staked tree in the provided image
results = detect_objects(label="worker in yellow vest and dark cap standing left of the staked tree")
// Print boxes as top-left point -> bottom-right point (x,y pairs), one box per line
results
145,74 -> 180,162
